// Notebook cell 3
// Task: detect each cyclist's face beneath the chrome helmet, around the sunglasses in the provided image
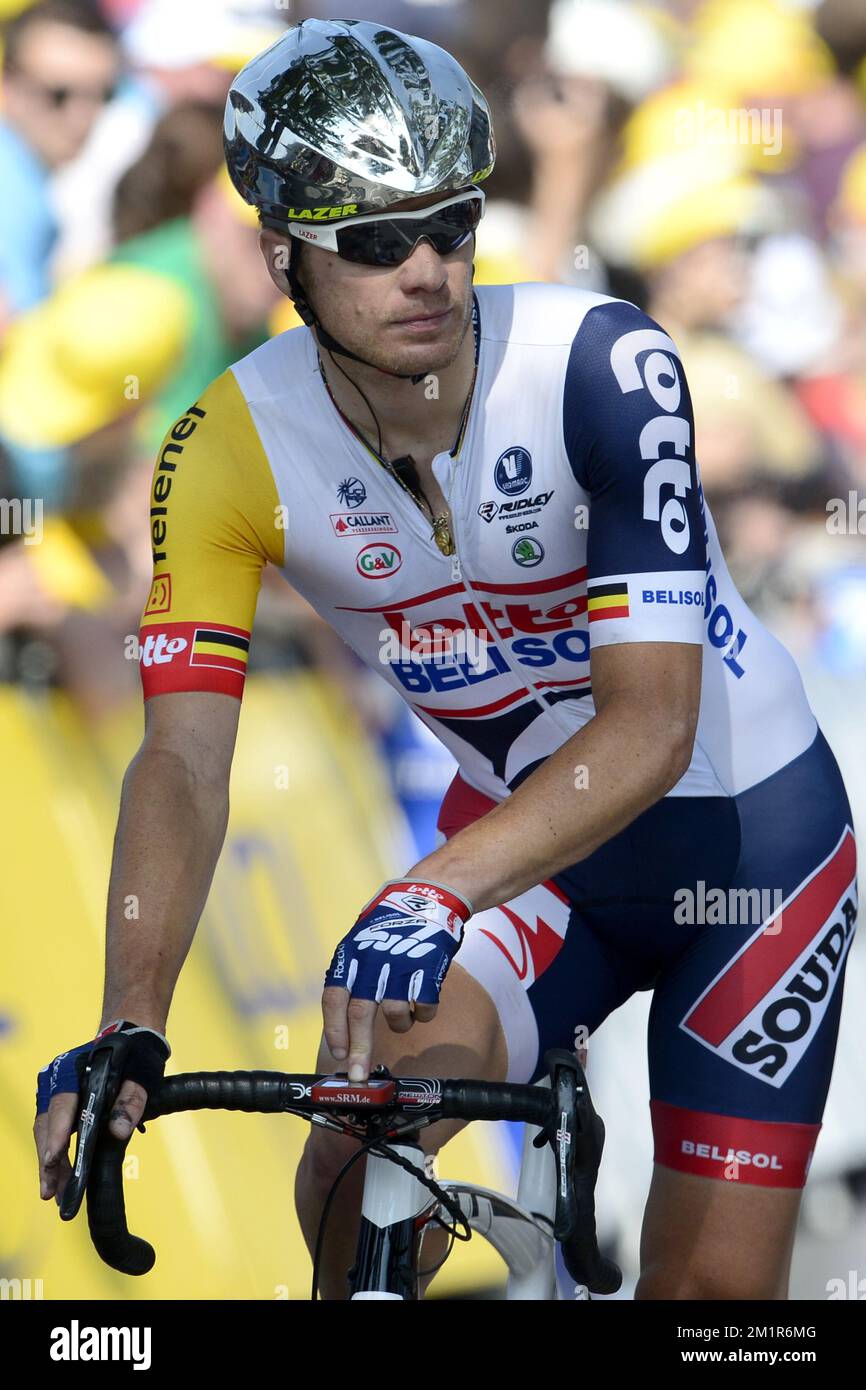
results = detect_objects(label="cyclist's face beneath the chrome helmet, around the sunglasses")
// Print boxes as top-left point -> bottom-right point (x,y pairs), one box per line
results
261,193 -> 474,374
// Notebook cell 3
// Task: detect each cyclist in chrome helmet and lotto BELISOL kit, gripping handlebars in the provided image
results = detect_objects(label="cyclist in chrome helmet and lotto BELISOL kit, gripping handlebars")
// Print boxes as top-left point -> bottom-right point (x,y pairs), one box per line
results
35,21 -> 856,1298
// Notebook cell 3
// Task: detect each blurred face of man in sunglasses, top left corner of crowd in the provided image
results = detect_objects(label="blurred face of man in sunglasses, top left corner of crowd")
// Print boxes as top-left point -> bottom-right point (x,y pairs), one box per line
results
3,19 -> 118,168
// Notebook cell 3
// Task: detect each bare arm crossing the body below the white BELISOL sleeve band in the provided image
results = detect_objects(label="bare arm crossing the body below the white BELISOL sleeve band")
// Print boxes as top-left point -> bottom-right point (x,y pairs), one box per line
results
410,642 -> 702,912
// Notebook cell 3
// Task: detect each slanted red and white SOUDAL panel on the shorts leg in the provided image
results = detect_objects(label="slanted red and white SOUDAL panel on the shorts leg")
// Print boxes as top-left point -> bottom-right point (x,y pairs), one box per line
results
680,826 -> 856,1087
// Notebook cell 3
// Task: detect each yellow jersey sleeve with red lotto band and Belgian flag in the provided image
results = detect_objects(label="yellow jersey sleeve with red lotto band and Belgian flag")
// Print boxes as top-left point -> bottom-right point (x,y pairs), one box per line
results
140,371 -> 285,699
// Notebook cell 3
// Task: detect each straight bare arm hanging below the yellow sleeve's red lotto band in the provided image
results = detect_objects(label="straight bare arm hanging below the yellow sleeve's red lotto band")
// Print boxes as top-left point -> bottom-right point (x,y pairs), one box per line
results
100,691 -> 240,1033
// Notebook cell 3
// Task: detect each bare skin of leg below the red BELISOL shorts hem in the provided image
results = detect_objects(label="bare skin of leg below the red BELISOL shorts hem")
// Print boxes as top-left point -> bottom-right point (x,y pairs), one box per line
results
635,1163 -> 802,1300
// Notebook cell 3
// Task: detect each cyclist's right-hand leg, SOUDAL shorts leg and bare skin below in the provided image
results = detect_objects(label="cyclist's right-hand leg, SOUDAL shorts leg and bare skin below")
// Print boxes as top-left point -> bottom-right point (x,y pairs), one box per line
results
638,737 -> 856,1298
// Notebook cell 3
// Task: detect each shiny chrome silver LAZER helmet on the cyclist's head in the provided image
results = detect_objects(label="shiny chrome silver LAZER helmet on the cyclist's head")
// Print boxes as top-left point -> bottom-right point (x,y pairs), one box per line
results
224,19 -> 496,228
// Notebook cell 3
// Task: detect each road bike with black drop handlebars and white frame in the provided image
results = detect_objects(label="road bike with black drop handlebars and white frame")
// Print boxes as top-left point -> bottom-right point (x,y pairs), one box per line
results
60,1034 -> 623,1301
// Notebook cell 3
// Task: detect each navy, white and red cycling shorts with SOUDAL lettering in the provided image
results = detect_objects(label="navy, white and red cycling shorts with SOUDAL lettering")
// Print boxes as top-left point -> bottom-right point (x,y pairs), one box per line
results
439,730 -> 856,1187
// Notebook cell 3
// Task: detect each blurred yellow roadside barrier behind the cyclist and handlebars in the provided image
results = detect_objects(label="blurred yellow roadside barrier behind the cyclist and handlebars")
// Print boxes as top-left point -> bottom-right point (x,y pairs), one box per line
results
0,674 -> 509,1300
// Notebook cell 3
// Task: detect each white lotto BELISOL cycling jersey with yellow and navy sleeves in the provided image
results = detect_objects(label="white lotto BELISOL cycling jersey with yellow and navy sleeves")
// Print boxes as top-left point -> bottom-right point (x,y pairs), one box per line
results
142,284 -> 816,799
